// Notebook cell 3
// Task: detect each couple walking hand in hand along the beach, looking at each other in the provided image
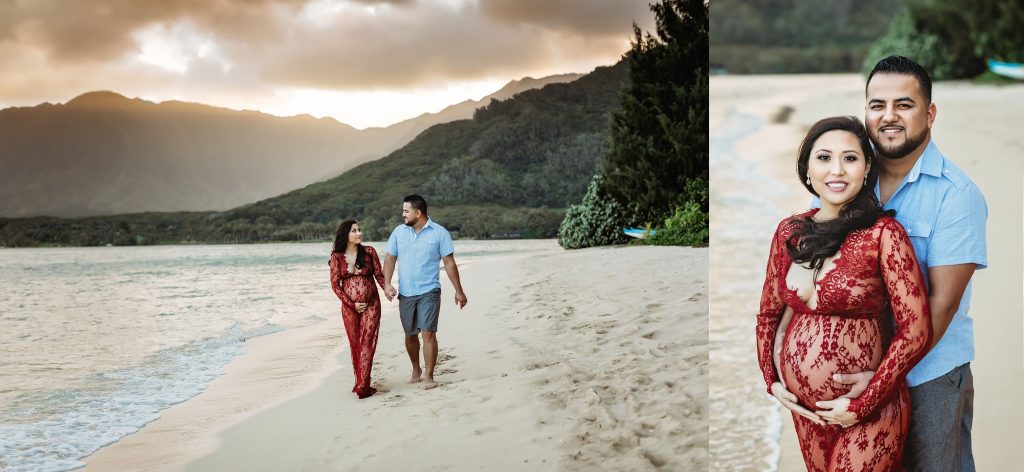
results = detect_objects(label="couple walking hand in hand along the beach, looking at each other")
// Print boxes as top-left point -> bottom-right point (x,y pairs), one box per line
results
330,195 -> 467,398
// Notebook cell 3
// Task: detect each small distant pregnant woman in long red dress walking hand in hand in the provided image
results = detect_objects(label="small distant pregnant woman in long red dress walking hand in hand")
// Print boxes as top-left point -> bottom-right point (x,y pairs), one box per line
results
330,220 -> 384,398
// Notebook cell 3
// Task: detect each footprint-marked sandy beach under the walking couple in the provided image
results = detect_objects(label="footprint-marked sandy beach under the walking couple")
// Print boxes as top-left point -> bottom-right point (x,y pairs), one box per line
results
86,242 -> 709,471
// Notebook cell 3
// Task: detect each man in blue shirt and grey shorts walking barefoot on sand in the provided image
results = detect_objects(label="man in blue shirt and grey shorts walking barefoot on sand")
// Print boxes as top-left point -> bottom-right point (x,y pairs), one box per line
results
384,195 -> 468,388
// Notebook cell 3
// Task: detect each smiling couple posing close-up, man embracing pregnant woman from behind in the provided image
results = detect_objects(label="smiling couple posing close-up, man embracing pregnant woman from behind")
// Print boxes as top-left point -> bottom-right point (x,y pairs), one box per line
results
757,56 -> 988,471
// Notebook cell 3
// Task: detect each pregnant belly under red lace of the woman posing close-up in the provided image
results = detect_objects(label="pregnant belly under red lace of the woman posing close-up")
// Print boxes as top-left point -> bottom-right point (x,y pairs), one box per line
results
780,314 -> 884,410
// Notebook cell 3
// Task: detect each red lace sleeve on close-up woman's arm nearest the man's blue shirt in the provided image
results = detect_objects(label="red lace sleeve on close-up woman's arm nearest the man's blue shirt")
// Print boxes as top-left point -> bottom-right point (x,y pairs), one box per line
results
849,219 -> 932,420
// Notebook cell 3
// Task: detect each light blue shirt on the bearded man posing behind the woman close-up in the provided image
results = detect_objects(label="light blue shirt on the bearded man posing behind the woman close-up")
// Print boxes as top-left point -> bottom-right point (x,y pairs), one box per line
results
813,140 -> 988,387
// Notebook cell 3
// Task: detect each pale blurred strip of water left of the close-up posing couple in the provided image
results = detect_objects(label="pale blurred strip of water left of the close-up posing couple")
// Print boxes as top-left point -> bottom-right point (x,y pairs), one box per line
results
709,112 -> 797,472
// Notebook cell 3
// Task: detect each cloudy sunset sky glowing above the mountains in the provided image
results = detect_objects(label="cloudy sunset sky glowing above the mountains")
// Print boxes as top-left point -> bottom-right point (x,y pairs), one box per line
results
0,0 -> 653,128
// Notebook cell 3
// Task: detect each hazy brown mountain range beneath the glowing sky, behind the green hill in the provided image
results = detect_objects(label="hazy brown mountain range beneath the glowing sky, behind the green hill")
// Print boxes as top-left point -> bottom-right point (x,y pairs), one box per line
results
0,75 -> 578,217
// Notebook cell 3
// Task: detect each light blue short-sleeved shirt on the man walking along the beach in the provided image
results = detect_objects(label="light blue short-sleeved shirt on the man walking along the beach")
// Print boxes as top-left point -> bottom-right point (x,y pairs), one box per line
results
385,218 -> 455,297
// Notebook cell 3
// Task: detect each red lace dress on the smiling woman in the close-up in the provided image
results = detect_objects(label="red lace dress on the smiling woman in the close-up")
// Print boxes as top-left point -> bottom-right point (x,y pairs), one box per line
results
757,210 -> 932,472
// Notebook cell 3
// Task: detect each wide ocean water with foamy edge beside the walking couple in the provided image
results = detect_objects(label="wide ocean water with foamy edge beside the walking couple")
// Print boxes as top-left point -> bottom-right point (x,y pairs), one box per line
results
0,241 -> 557,471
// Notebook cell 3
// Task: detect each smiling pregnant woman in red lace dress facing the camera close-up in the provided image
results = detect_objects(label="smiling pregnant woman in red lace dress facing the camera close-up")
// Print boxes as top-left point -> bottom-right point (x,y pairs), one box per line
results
757,117 -> 932,471
